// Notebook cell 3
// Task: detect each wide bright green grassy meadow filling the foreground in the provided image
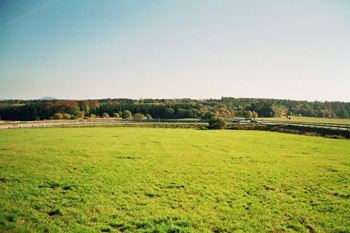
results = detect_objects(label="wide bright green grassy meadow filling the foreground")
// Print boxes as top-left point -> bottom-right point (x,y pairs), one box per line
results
0,128 -> 350,232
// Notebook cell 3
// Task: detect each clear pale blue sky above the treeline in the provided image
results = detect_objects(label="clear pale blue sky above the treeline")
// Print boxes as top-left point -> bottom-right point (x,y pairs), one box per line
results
0,0 -> 350,102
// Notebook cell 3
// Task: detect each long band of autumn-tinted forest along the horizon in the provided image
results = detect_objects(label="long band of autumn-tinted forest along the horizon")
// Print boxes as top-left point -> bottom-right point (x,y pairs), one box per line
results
0,97 -> 350,121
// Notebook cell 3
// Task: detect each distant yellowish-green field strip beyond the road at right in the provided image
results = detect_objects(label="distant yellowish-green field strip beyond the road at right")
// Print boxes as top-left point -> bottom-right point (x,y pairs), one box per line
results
257,116 -> 350,124
